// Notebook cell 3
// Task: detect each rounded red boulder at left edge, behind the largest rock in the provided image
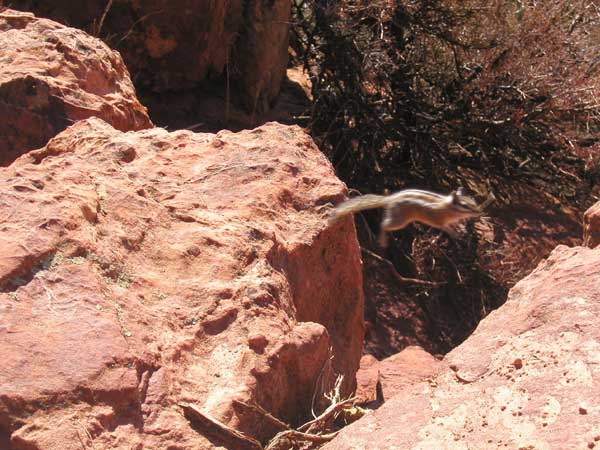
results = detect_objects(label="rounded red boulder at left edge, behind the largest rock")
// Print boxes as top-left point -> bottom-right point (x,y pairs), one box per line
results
0,9 -> 152,165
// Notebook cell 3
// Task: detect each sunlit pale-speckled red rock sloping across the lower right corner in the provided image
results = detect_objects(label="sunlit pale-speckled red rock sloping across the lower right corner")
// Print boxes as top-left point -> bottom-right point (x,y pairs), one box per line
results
323,246 -> 600,450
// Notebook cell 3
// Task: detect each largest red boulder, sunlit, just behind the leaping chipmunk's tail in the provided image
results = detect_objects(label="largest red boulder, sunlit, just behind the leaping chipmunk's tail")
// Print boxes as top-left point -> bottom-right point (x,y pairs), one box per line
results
0,118 -> 364,450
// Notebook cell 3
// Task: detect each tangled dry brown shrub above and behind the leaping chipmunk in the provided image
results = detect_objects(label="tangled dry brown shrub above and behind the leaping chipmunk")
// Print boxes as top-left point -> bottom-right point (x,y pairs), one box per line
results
294,0 -> 600,202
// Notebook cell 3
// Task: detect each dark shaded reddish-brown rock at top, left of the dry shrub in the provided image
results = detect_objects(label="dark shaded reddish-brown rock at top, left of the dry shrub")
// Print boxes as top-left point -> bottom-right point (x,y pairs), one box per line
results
11,0 -> 291,112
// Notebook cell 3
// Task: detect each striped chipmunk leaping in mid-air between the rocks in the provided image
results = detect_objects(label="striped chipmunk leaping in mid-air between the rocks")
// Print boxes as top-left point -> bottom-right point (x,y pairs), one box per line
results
329,188 -> 493,247
